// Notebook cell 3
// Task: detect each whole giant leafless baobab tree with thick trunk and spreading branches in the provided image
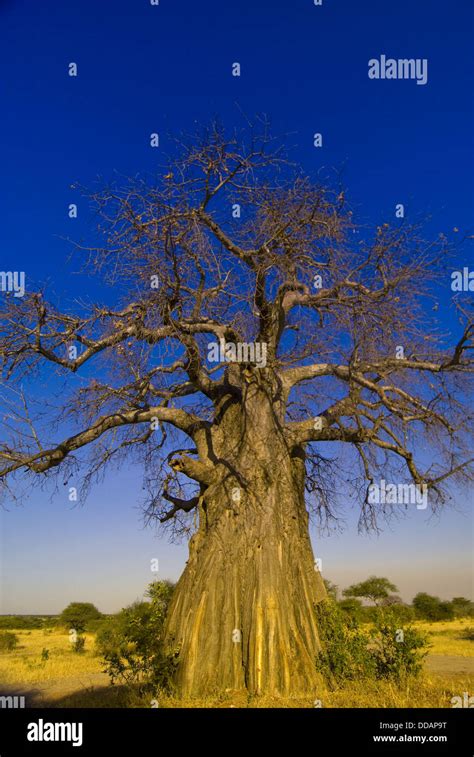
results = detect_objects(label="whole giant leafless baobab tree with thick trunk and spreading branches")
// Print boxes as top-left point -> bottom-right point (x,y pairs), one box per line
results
0,125 -> 473,697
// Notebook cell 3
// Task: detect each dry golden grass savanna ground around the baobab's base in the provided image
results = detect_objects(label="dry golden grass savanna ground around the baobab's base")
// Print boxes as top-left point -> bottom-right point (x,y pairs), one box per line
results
0,619 -> 474,708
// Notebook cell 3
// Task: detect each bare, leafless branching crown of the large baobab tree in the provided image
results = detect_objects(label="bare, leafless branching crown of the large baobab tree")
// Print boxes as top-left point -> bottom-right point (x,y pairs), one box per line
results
0,124 -> 473,530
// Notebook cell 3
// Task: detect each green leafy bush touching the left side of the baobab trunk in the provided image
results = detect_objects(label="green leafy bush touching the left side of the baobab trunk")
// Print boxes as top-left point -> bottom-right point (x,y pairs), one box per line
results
96,581 -> 178,691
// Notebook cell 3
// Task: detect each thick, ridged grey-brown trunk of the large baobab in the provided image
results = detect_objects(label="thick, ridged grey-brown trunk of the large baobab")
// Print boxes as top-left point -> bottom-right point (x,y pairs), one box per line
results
166,376 -> 325,697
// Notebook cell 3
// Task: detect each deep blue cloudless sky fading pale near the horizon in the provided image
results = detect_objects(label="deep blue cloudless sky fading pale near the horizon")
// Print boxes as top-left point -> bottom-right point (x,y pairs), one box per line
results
0,0 -> 474,612
